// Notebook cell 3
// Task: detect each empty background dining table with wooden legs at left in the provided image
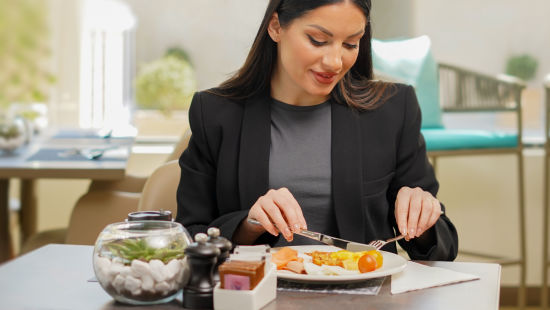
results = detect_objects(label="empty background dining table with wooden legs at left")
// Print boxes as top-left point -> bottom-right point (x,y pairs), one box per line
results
0,128 -> 135,263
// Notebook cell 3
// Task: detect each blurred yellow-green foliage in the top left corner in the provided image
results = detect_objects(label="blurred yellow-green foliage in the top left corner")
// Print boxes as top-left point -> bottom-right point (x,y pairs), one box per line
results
0,0 -> 55,109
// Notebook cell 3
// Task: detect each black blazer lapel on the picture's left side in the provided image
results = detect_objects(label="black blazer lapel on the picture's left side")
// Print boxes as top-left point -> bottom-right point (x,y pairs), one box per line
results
239,96 -> 271,210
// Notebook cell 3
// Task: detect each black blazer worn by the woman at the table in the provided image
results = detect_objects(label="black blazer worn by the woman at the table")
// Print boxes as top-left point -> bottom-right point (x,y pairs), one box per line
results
176,84 -> 458,260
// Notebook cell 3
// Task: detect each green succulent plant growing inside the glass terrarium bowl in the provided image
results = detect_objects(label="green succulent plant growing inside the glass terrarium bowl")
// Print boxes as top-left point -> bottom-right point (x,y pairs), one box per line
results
105,238 -> 185,264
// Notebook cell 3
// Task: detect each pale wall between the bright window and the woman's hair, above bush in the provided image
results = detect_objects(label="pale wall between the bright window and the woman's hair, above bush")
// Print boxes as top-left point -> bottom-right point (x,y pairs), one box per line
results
126,0 -> 267,89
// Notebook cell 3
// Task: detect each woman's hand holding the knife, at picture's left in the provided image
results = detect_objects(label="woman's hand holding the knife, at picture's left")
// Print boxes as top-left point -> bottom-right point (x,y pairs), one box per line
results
245,187 -> 307,242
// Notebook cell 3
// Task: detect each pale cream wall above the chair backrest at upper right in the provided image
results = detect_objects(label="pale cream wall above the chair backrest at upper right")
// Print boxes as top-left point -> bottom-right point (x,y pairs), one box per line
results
412,0 -> 550,87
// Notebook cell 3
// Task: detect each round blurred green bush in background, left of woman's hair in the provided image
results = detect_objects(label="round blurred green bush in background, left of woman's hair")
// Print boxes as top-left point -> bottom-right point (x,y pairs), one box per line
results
135,50 -> 197,116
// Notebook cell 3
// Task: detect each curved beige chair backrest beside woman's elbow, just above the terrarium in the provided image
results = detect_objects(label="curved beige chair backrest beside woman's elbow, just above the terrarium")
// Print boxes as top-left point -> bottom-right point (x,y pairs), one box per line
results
138,160 -> 180,216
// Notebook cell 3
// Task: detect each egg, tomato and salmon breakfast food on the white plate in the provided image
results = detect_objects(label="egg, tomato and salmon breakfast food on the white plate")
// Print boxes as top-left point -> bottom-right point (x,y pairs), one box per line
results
272,247 -> 383,275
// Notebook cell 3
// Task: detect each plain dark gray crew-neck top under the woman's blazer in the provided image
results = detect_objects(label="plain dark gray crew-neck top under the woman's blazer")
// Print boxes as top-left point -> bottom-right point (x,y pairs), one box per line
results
269,99 -> 338,246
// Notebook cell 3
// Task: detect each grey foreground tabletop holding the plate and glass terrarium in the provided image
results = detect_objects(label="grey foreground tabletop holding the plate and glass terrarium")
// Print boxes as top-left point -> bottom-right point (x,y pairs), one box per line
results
0,244 -> 501,310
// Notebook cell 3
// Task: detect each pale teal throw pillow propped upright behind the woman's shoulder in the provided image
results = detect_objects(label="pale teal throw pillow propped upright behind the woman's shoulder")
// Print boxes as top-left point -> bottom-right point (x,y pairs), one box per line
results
372,36 -> 443,128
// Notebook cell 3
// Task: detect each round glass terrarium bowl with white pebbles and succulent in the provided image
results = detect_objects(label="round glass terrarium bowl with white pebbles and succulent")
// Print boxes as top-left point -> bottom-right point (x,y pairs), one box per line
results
93,221 -> 192,305
